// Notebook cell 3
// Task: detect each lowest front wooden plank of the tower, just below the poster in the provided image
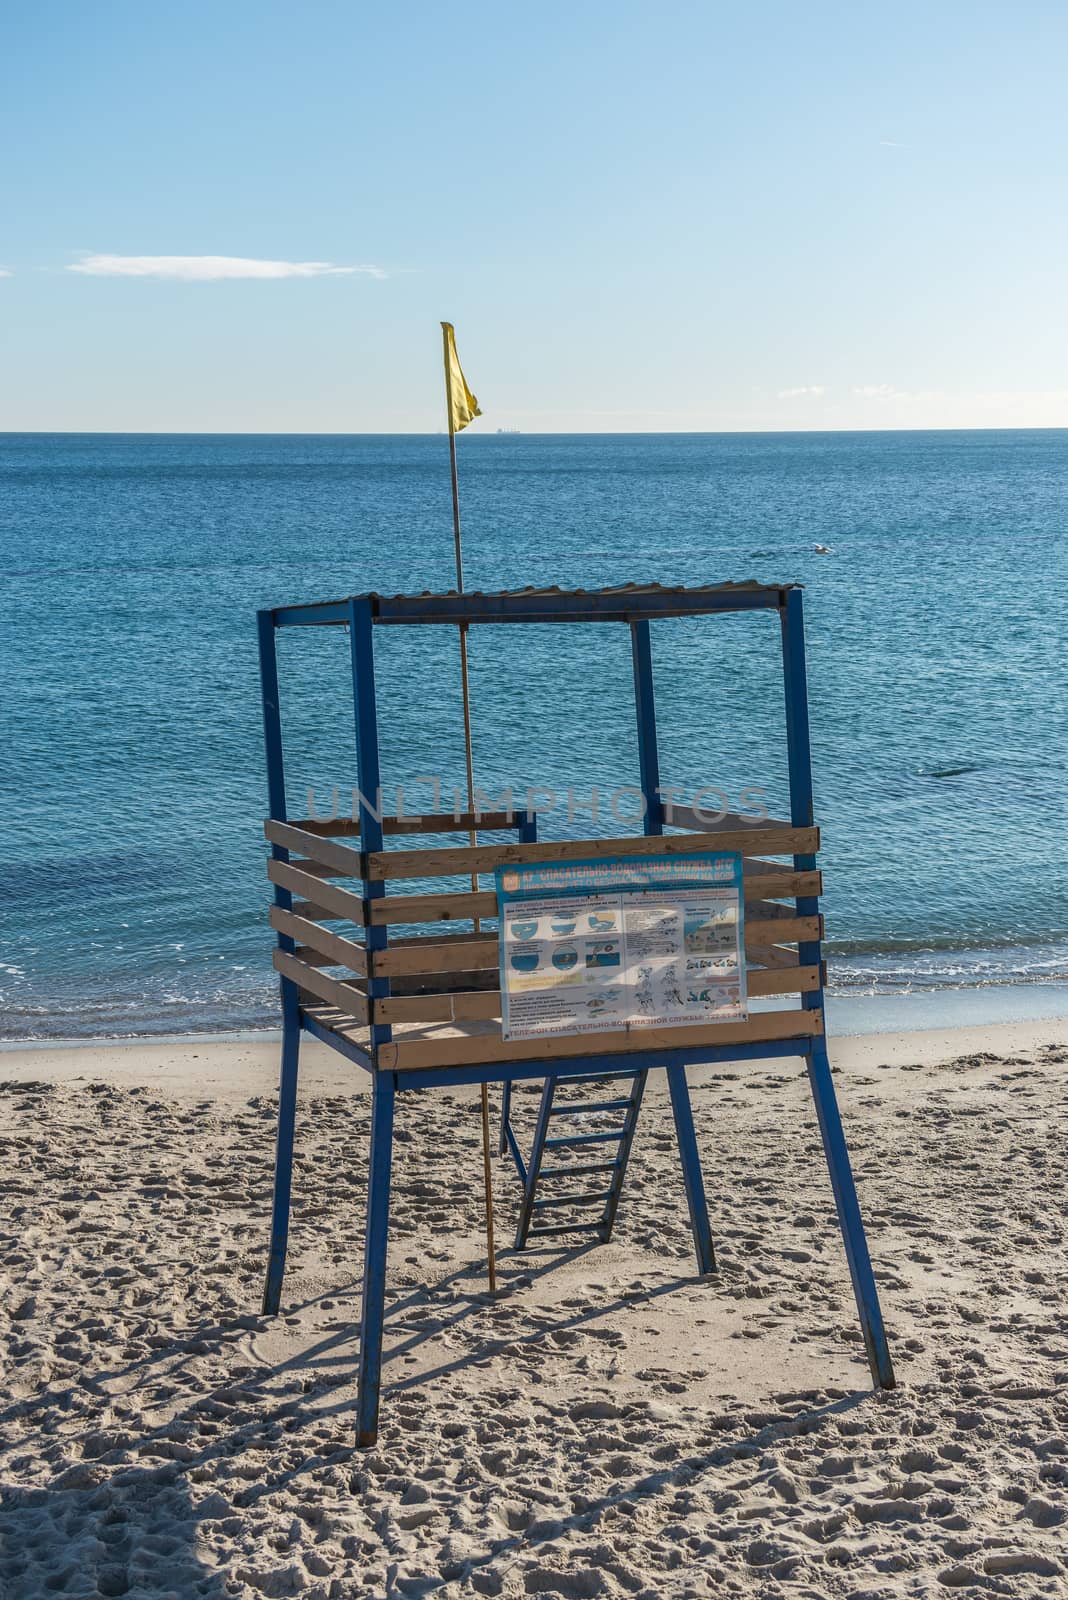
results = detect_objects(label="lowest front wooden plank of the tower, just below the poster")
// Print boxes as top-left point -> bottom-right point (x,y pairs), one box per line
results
377,1010 -> 823,1072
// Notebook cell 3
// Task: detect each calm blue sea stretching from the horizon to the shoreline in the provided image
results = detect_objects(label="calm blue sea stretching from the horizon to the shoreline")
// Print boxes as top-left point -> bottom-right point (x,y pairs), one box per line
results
0,432 -> 1068,1037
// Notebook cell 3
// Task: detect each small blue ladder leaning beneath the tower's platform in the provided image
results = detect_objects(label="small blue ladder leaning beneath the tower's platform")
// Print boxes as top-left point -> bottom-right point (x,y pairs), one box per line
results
500,1070 -> 648,1250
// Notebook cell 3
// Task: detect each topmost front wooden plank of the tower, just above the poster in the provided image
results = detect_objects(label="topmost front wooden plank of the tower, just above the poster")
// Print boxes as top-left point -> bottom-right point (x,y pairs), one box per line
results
366,824 -> 820,883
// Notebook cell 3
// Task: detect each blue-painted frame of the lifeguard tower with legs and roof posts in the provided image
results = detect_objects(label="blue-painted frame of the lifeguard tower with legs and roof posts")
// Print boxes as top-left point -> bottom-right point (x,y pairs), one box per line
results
257,586 -> 894,1445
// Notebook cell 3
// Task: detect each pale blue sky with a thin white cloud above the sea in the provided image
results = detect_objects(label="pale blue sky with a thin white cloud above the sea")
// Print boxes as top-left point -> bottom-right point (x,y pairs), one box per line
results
0,0 -> 1068,434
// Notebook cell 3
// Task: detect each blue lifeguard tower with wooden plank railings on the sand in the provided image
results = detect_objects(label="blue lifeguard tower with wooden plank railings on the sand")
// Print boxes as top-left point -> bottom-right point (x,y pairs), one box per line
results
259,582 -> 894,1445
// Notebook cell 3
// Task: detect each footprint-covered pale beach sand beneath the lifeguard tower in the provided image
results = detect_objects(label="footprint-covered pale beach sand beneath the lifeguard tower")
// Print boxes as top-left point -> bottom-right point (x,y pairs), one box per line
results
0,1022 -> 1068,1600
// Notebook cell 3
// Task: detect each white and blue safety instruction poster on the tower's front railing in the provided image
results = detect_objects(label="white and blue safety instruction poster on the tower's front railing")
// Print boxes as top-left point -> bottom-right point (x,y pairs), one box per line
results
496,851 -> 747,1038
